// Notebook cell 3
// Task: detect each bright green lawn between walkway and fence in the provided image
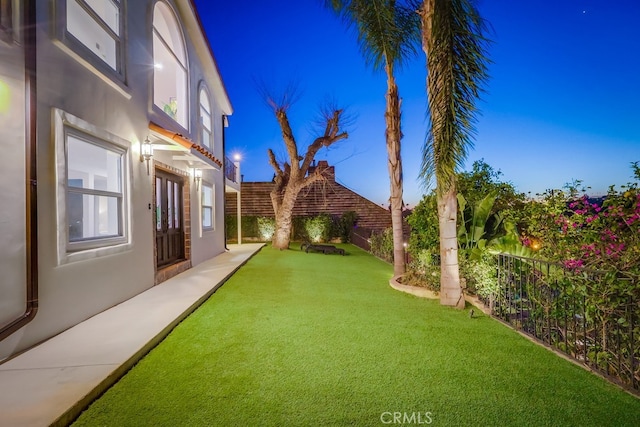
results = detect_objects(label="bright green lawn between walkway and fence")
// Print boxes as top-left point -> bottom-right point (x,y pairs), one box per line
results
76,244 -> 640,426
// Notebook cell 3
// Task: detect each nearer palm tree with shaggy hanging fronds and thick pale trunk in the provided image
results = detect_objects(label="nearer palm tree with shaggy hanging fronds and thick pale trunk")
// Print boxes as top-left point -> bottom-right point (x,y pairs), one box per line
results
418,0 -> 490,308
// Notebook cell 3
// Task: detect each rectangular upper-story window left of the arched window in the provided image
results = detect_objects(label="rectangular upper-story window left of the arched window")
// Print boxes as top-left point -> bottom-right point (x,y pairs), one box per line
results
59,0 -> 124,75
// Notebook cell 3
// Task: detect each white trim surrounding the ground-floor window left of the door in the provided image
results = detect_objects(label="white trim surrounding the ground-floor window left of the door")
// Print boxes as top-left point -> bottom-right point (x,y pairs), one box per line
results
53,108 -> 132,265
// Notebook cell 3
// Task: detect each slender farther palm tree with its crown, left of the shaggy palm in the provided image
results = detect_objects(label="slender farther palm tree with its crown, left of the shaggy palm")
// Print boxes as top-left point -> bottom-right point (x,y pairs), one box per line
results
325,0 -> 420,275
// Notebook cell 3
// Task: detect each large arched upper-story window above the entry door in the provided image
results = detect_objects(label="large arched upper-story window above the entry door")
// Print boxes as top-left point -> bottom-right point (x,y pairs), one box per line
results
153,1 -> 189,129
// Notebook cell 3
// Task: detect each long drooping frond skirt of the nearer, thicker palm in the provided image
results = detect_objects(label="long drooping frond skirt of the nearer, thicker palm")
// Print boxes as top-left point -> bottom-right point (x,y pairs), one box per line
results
420,0 -> 490,192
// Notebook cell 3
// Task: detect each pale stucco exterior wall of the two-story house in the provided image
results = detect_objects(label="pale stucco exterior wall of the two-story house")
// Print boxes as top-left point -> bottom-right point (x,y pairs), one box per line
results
0,0 -> 232,360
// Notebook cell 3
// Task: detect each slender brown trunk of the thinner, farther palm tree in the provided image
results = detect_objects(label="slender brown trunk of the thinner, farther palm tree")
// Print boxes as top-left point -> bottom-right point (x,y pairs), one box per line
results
384,69 -> 406,276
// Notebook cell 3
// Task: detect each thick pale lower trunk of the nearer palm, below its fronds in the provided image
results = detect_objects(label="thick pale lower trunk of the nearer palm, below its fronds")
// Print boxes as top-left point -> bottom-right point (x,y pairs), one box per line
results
437,185 -> 464,309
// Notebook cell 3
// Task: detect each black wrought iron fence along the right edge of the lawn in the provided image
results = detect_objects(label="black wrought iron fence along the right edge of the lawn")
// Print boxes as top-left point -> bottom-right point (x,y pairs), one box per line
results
492,255 -> 640,392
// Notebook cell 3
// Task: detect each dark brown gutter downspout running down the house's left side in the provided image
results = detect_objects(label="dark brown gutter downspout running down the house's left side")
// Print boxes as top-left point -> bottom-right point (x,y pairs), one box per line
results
0,0 -> 38,341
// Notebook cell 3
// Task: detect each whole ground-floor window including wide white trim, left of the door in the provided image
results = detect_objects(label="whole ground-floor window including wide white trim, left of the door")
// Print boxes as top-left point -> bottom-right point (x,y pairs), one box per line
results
53,108 -> 132,265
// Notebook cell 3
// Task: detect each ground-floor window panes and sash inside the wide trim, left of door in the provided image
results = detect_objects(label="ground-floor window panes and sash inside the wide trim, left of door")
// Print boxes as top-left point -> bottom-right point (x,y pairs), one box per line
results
65,128 -> 125,251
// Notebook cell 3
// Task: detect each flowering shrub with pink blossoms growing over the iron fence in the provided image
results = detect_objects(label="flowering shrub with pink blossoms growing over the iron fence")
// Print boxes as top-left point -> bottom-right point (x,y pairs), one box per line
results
508,169 -> 640,392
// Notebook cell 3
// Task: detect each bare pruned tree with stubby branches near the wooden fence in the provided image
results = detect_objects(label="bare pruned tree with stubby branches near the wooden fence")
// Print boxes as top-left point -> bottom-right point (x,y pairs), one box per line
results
266,96 -> 348,249
